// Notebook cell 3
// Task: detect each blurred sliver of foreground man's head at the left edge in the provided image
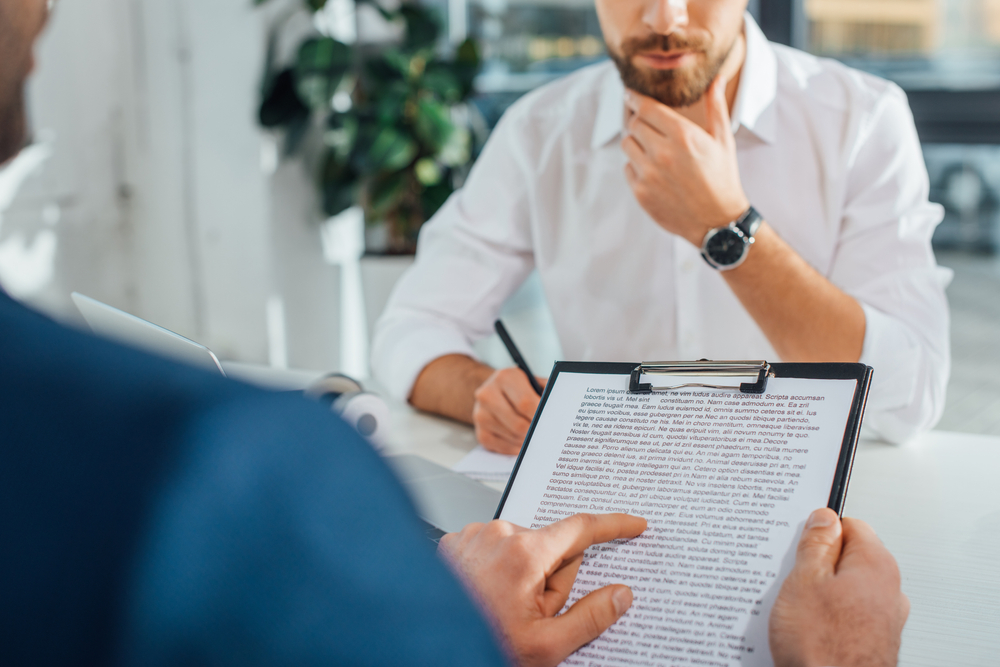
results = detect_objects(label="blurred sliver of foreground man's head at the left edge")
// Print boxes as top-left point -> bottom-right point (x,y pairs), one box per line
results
0,0 -> 49,164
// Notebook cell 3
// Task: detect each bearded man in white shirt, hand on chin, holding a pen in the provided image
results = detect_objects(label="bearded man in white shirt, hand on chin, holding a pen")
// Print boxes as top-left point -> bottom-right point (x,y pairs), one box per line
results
373,0 -> 950,453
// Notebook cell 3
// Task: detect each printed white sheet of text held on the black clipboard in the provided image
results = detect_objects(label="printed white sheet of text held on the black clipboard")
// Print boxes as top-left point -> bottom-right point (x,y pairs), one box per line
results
501,373 -> 856,667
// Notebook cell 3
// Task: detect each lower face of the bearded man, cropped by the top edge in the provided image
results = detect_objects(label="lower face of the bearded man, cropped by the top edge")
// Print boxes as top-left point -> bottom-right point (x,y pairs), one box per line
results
596,0 -> 748,108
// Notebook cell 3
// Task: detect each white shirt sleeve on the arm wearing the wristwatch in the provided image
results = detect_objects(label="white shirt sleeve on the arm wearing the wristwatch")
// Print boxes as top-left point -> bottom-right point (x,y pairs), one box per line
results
831,86 -> 951,443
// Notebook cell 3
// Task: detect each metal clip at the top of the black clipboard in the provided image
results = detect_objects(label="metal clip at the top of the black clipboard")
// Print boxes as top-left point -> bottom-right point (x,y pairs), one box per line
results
628,359 -> 774,394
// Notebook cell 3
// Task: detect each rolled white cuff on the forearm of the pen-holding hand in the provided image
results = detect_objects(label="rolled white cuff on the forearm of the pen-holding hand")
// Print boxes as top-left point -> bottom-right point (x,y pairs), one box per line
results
372,318 -> 477,401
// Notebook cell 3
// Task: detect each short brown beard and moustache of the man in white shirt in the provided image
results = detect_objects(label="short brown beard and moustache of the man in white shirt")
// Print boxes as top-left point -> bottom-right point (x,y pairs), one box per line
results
608,35 -> 735,109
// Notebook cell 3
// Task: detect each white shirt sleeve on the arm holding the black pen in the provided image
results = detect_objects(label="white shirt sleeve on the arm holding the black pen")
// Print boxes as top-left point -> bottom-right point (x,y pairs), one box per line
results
372,112 -> 534,399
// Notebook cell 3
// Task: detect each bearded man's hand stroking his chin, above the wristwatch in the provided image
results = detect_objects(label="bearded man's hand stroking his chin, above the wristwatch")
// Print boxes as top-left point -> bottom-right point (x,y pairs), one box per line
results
622,77 -> 750,248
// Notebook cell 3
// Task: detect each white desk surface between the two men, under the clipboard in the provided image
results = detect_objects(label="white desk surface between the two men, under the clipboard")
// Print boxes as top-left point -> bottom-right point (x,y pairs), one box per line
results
378,396 -> 1000,667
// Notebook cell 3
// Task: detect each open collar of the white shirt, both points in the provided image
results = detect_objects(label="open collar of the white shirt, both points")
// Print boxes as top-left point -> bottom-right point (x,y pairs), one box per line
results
591,12 -> 778,150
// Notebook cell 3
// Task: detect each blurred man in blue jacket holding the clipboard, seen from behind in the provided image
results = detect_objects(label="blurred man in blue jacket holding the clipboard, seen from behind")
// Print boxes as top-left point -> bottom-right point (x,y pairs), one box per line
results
0,0 -> 906,667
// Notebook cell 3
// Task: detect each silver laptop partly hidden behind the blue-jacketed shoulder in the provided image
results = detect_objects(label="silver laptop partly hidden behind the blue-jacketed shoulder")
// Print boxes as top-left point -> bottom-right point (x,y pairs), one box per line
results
72,292 -> 501,542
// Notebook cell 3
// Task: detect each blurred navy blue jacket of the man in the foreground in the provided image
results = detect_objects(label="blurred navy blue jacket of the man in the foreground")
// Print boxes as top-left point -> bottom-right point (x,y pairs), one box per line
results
0,293 -> 504,666
